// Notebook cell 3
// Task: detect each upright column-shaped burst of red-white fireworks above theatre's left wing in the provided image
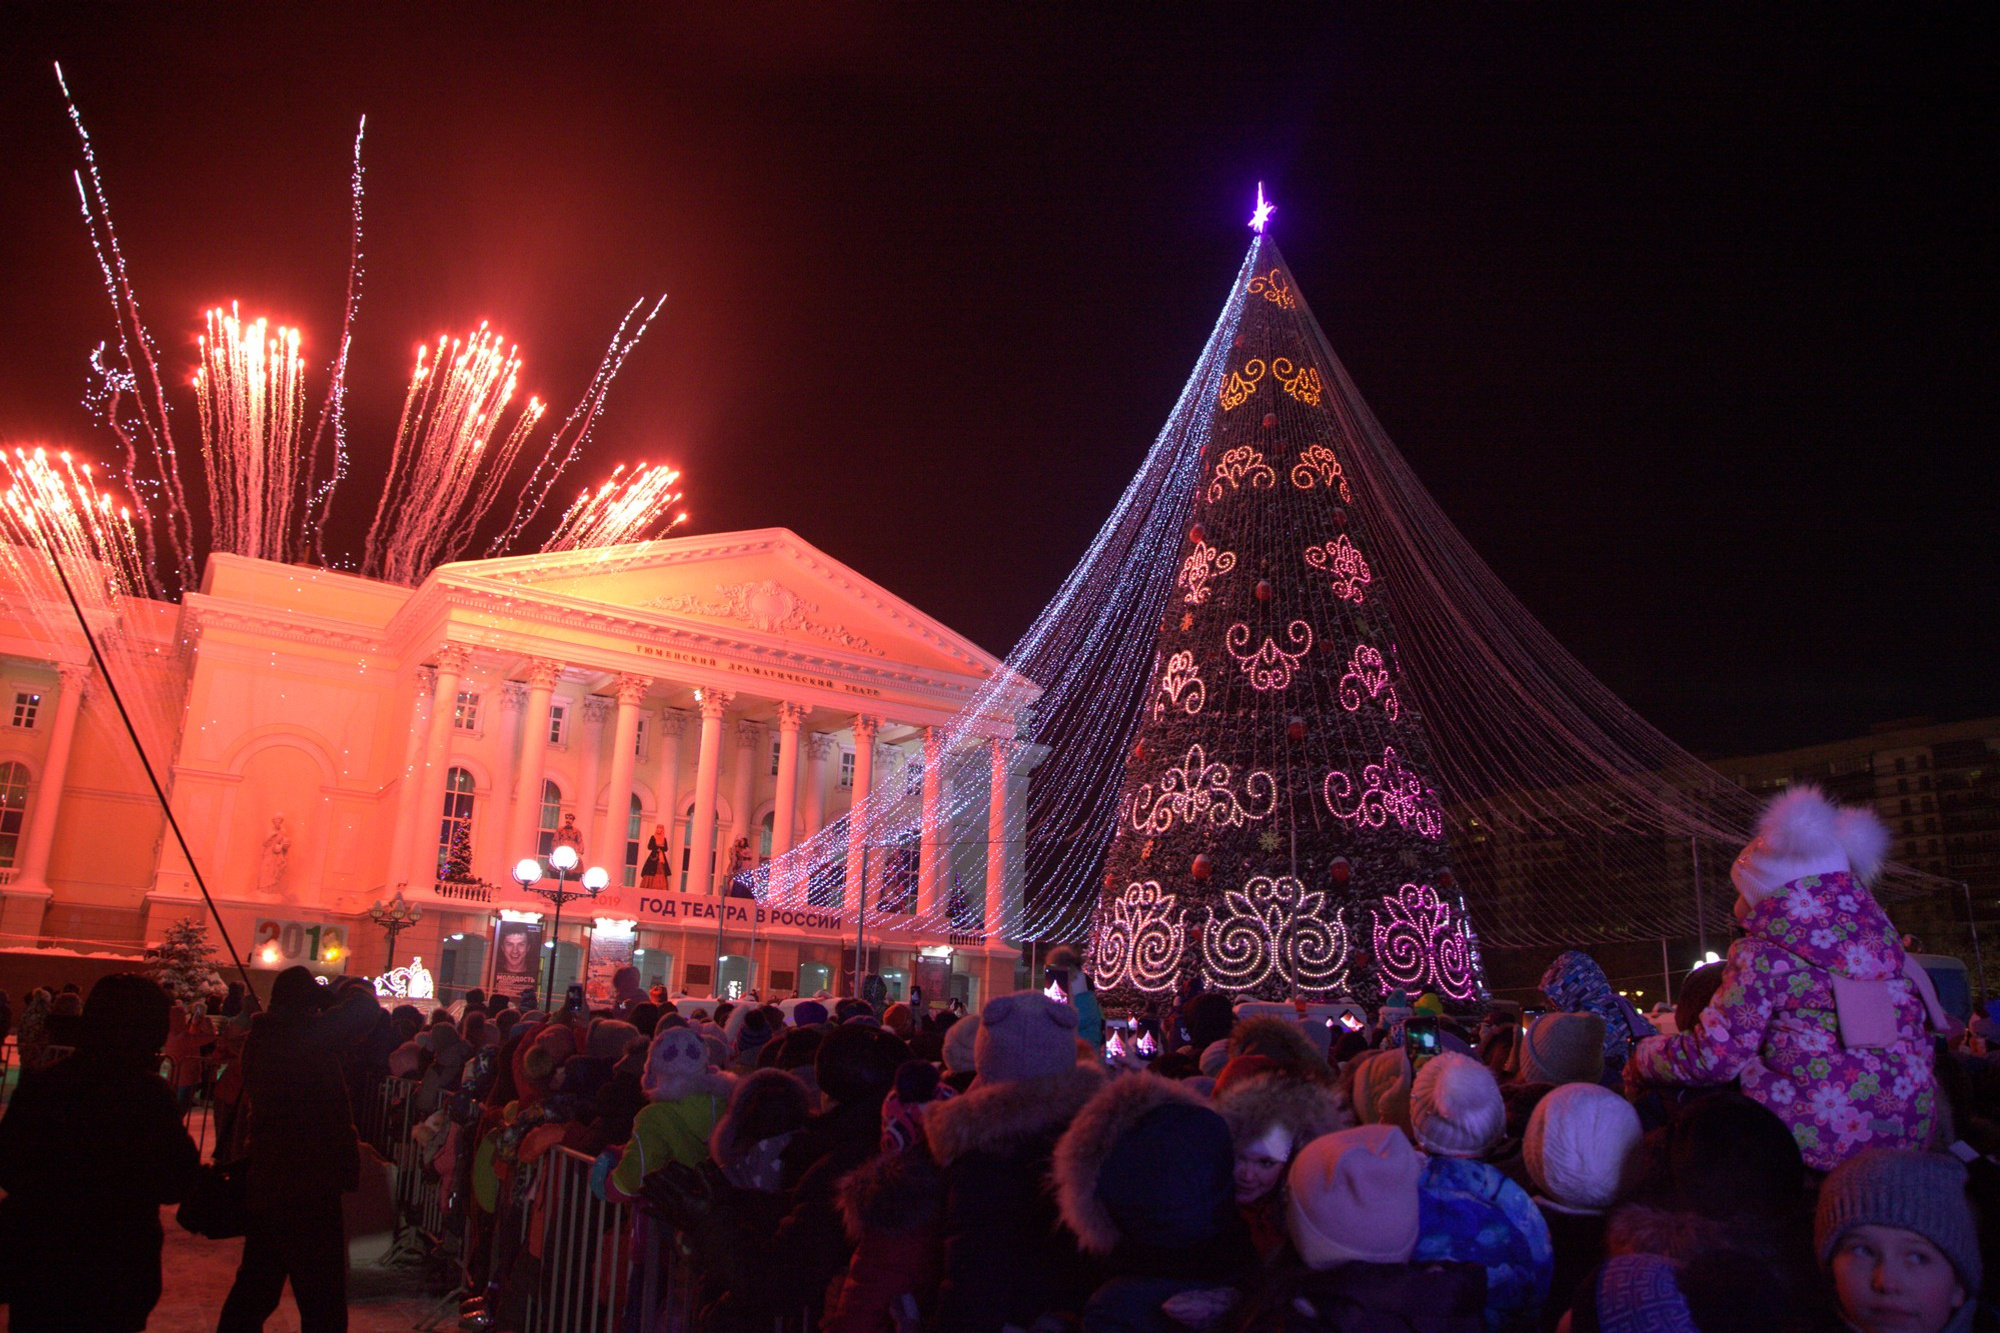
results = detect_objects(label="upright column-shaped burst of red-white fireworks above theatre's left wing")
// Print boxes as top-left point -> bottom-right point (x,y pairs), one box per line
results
194,306 -> 308,560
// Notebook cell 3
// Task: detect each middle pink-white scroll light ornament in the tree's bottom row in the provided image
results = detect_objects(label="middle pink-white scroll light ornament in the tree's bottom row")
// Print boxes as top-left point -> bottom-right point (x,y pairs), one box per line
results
1202,875 -> 1352,993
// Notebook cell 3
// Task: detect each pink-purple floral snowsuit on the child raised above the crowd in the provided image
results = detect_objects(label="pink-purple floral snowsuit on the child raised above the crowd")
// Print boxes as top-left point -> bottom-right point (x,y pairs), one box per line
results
1626,873 -> 1938,1171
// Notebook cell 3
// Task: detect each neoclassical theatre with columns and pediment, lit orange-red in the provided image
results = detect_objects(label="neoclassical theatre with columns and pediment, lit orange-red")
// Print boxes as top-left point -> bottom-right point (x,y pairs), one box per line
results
0,528 -> 1036,1005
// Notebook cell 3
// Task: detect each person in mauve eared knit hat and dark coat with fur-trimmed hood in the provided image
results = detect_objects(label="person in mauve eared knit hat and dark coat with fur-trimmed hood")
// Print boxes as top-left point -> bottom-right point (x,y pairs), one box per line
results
924,991 -> 1104,1333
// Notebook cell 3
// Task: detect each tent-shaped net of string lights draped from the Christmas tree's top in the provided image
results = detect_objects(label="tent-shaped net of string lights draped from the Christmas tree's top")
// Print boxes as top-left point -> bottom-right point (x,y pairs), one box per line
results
756,236 -> 1942,964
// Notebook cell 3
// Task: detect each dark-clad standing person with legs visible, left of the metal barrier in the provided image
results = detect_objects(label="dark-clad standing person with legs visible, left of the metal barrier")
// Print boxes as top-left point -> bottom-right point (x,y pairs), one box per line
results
216,967 -> 380,1333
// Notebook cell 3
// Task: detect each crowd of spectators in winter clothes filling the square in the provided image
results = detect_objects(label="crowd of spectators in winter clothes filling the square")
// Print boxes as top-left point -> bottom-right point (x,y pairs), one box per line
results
0,793 -> 2000,1333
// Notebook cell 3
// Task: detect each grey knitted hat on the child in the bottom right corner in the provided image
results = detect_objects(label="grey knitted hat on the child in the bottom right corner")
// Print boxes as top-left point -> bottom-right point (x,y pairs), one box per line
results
1812,1149 -> 1980,1291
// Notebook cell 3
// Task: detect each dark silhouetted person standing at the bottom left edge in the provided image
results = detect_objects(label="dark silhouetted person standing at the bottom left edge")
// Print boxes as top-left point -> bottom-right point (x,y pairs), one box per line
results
0,973 -> 200,1333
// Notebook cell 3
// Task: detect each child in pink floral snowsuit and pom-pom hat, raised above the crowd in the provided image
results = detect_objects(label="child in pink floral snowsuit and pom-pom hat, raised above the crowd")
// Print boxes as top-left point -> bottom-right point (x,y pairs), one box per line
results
1626,787 -> 1944,1171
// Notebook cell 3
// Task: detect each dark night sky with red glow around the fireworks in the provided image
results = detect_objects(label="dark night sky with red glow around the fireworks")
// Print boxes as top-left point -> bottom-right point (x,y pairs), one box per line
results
0,4 -> 2000,755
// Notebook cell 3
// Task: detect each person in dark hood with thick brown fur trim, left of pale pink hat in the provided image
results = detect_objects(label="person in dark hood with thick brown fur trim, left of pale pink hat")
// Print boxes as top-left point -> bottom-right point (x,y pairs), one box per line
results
1052,1073 -> 1258,1333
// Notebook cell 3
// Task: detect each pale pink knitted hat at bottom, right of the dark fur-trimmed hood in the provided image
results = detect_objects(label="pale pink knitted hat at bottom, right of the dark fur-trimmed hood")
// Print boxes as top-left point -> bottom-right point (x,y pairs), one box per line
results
1284,1125 -> 1424,1269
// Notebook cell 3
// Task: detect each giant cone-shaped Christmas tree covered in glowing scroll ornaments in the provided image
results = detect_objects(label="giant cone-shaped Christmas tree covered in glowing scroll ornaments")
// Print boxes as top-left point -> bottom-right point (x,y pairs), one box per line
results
1092,223 -> 1480,1005
